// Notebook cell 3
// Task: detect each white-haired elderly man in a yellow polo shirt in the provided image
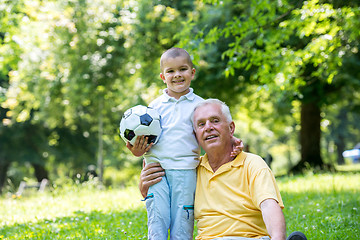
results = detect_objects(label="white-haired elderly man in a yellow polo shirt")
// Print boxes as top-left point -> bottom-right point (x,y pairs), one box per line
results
139,99 -> 306,240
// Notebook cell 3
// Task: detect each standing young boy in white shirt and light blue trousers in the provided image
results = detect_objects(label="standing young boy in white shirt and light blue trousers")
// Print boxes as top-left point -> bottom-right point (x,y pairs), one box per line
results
127,48 -> 242,240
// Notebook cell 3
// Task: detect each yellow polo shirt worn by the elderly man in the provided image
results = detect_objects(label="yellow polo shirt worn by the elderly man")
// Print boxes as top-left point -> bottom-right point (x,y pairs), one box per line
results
195,152 -> 284,239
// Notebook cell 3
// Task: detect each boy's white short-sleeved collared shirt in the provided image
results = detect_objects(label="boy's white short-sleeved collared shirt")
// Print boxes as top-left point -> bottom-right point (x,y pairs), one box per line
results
145,88 -> 203,169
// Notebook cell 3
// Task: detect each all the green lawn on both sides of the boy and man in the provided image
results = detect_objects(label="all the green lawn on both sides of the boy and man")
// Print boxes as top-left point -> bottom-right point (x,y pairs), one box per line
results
0,173 -> 360,240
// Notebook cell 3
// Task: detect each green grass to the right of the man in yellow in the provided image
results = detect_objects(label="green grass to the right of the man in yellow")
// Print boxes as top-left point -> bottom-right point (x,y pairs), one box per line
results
278,173 -> 360,239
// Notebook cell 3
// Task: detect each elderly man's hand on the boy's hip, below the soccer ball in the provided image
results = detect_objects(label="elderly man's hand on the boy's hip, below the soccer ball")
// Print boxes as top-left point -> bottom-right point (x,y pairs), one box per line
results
139,160 -> 165,197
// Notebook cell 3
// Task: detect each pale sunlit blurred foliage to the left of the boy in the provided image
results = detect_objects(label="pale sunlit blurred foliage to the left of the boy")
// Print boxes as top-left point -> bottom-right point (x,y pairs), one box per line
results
1,0 -> 192,189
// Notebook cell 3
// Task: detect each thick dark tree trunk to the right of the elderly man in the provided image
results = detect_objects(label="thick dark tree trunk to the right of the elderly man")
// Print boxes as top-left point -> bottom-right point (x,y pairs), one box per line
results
290,102 -> 324,172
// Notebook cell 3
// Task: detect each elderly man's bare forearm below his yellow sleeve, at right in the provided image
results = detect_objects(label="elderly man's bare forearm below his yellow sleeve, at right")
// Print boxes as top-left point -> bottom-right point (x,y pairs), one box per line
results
260,198 -> 286,240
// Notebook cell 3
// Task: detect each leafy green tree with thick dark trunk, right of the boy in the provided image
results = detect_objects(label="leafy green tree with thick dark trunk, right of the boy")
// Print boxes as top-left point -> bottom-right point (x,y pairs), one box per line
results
176,0 -> 360,171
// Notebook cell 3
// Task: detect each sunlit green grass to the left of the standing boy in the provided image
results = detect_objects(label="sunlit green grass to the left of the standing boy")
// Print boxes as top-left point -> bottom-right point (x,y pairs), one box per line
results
0,182 -> 147,239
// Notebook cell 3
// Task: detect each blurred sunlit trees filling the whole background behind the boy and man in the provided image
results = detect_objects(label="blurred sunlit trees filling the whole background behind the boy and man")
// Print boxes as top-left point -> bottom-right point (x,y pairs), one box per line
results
0,0 -> 360,192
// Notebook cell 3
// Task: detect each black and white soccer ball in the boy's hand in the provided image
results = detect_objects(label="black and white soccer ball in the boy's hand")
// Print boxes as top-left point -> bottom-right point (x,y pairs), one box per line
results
120,105 -> 161,145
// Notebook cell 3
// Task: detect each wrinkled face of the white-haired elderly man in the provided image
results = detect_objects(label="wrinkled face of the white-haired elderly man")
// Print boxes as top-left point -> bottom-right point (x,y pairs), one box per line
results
194,103 -> 235,152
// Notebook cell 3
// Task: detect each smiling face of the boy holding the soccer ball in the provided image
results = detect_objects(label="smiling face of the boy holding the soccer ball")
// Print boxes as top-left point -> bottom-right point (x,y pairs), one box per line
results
160,56 -> 195,99
